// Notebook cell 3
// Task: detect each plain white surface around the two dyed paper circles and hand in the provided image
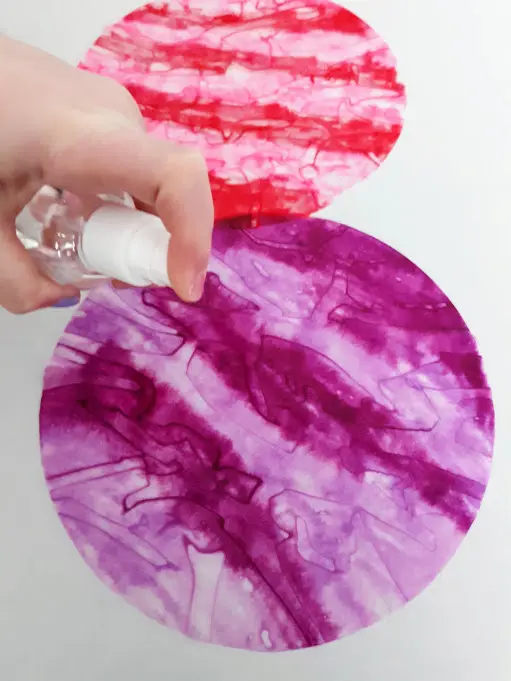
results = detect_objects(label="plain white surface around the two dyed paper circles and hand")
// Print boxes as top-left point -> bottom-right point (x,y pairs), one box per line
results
0,0 -> 511,681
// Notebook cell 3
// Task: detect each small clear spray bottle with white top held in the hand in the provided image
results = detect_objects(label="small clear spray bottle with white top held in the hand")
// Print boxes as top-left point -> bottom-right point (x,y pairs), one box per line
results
16,187 -> 170,289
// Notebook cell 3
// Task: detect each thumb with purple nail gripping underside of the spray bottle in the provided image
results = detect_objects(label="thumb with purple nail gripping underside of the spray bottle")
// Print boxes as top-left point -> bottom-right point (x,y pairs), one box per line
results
0,222 -> 79,314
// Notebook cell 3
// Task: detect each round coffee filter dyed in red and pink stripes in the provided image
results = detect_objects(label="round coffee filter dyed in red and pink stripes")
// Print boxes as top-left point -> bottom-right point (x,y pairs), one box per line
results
82,0 -> 405,223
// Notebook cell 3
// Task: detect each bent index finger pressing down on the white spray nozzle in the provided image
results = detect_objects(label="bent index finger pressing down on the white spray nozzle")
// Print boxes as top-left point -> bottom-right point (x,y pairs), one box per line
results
44,117 -> 213,301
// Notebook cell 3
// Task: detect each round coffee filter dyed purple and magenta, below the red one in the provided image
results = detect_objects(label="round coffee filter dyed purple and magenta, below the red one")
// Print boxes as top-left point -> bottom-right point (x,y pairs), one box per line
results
41,218 -> 493,651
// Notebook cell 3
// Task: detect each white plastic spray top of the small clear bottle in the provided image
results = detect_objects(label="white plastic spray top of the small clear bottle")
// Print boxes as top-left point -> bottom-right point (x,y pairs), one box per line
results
80,204 -> 171,286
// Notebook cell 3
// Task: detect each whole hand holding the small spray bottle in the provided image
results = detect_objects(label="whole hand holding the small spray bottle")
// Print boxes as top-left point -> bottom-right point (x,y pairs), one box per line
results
0,36 -> 213,313
